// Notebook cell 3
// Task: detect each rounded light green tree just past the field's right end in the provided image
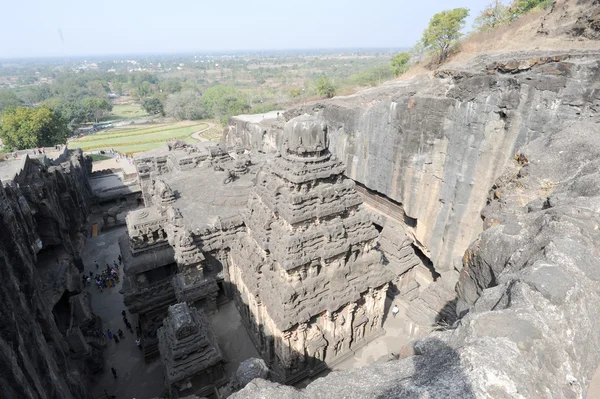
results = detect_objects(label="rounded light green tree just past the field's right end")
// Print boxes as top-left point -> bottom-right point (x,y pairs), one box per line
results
202,85 -> 250,124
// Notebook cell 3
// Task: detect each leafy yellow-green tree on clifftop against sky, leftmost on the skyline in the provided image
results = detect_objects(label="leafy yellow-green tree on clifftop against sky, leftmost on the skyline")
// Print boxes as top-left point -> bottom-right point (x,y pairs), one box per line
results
421,8 -> 469,63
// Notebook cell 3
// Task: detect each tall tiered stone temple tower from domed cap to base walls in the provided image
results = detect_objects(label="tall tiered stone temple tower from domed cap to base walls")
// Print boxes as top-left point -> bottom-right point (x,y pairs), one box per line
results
228,116 -> 395,383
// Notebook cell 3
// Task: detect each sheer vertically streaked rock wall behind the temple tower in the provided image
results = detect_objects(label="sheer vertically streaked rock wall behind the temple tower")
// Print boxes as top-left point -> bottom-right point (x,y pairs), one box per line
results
224,51 -> 600,271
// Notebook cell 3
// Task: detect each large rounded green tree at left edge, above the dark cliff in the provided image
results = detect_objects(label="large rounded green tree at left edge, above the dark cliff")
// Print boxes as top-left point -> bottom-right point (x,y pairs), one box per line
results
0,107 -> 69,151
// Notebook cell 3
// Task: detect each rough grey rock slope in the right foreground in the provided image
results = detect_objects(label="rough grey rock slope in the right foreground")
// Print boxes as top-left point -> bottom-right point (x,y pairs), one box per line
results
234,115 -> 600,398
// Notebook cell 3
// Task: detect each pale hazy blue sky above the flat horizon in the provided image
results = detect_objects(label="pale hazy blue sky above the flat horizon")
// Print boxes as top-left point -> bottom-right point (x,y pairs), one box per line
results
0,0 -> 488,58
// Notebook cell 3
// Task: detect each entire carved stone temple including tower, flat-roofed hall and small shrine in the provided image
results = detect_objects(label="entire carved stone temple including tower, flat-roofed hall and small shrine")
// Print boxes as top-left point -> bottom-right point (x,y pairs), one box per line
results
119,115 -> 415,394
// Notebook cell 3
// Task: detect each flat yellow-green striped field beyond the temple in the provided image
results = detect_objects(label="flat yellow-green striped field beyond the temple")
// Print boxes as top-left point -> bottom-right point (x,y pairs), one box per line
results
68,122 -> 208,154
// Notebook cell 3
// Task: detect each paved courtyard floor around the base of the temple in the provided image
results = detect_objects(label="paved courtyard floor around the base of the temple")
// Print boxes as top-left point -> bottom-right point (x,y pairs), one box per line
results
78,227 -> 406,399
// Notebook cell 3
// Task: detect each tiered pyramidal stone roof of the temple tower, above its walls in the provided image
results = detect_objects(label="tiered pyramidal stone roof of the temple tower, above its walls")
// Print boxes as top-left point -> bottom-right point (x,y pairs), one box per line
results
231,116 -> 395,331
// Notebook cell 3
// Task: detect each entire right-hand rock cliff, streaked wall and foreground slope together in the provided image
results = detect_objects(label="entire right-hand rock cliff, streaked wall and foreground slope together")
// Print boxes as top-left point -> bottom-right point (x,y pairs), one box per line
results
224,1 -> 600,399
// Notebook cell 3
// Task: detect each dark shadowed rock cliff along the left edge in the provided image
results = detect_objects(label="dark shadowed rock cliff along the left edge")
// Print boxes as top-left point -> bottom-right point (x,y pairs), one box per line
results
0,150 -> 91,398
